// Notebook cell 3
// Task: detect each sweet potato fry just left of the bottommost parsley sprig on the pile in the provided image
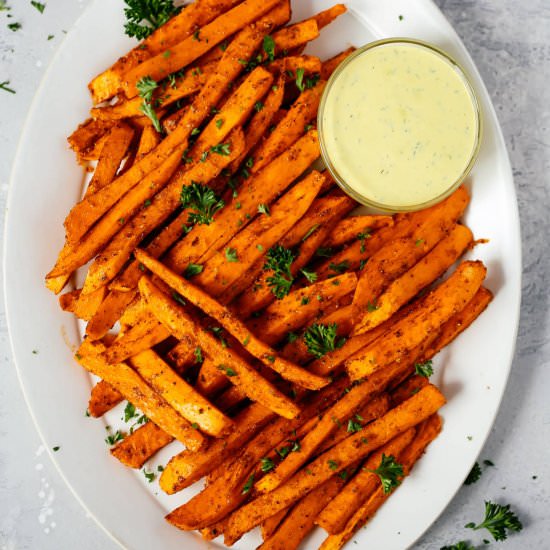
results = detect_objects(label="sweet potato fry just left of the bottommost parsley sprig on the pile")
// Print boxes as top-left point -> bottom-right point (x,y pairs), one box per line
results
315,428 -> 416,535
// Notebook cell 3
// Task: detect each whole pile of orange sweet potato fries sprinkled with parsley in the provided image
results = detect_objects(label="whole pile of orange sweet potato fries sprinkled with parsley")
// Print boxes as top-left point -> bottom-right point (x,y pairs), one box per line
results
46,0 -> 491,550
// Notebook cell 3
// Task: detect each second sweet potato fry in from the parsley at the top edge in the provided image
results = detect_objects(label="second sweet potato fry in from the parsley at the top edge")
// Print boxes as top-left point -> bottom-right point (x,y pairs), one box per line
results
122,0 -> 279,98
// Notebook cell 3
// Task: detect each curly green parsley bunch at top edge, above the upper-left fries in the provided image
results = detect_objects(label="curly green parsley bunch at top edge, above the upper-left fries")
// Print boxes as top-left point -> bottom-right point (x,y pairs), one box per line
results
123,0 -> 181,40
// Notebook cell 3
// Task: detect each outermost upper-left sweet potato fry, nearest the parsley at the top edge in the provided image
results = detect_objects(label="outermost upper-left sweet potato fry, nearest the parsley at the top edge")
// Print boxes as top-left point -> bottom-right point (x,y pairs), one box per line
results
88,0 -> 244,103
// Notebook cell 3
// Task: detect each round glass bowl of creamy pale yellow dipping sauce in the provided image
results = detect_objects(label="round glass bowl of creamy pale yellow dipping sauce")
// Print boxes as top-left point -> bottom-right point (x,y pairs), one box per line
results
319,39 -> 480,211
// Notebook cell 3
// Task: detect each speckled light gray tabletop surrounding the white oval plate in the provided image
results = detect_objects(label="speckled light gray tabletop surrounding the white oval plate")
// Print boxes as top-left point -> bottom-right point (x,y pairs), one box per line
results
0,0 -> 550,550
